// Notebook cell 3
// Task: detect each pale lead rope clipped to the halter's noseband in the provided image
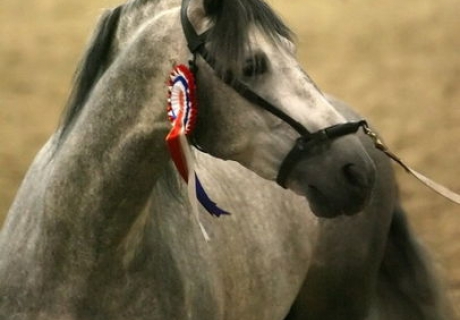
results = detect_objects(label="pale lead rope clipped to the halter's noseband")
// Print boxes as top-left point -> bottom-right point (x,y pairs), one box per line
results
363,124 -> 460,204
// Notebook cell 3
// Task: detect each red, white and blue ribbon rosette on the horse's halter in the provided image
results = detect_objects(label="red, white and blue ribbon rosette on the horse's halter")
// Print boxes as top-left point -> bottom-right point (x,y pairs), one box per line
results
166,65 -> 228,238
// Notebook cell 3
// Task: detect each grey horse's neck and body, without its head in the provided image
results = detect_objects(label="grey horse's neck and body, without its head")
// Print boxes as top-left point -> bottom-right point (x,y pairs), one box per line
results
0,1 -> 452,320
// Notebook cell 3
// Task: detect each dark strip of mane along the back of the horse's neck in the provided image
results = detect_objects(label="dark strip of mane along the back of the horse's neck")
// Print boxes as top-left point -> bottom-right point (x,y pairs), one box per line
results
58,6 -> 122,146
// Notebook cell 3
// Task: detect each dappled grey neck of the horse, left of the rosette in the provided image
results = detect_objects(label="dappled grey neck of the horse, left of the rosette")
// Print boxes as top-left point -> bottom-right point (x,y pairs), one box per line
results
4,6 -> 187,258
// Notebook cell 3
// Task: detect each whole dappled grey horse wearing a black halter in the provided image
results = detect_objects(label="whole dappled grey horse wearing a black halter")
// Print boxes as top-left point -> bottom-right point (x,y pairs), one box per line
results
0,0 -> 448,320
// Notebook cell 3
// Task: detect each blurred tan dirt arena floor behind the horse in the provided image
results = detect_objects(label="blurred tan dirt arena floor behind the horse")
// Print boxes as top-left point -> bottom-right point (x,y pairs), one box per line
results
0,0 -> 460,316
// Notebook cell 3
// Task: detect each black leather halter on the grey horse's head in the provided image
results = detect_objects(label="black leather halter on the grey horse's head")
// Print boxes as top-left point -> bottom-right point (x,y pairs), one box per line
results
181,0 -> 367,188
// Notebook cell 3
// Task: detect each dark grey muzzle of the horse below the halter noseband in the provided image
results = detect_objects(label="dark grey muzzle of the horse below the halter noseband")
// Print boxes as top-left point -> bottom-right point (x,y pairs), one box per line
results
278,135 -> 376,218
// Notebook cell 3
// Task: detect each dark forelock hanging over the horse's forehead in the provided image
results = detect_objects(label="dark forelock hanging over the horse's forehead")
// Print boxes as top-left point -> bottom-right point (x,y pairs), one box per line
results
204,0 -> 293,73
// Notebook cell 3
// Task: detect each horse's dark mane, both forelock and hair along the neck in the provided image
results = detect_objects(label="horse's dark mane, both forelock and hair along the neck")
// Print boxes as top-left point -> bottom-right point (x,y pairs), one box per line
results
57,0 -> 292,147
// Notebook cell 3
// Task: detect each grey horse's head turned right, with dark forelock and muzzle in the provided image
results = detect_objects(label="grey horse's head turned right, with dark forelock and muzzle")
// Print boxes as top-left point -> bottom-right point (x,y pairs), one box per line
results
178,0 -> 375,217
